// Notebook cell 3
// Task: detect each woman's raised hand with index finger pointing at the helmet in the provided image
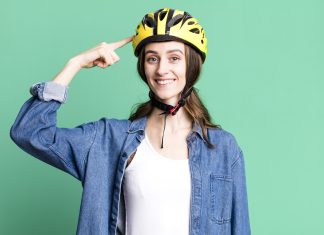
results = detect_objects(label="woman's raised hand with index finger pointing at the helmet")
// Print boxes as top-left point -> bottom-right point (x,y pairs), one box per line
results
73,36 -> 134,68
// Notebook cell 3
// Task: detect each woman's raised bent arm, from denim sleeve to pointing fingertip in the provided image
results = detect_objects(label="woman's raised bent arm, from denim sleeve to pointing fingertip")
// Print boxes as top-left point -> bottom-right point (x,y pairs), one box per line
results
10,37 -> 132,181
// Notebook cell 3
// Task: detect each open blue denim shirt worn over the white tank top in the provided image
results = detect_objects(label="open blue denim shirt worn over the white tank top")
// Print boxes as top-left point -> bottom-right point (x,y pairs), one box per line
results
10,82 -> 251,235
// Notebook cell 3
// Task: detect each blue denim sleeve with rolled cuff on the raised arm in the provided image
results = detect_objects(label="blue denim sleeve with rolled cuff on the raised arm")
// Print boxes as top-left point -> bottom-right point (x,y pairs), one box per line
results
10,82 -> 97,182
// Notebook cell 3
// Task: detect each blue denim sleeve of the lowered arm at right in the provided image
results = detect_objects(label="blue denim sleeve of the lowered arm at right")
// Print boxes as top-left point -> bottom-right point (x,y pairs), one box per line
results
232,146 -> 251,235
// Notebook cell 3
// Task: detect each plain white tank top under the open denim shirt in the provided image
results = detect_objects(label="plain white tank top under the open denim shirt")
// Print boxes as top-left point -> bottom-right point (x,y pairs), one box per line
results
123,132 -> 191,235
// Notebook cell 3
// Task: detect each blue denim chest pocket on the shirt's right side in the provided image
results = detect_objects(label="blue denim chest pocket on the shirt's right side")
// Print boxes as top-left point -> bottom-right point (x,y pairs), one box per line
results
209,174 -> 233,224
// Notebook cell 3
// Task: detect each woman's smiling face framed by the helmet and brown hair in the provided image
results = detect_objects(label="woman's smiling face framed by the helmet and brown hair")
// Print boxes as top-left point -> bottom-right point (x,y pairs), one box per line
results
144,41 -> 186,105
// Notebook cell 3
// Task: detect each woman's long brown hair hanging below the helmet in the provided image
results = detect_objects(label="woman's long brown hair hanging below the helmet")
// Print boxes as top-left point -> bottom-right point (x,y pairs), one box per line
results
128,44 -> 221,148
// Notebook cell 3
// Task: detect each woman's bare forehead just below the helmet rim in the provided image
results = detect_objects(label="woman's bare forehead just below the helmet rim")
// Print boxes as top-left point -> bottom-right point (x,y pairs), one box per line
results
145,41 -> 185,54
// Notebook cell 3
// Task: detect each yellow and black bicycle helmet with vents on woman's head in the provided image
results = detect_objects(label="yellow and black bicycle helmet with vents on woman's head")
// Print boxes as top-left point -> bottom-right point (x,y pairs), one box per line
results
133,8 -> 207,62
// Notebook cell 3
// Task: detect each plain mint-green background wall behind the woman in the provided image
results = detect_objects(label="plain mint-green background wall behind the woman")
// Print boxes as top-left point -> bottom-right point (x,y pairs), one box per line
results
0,0 -> 324,235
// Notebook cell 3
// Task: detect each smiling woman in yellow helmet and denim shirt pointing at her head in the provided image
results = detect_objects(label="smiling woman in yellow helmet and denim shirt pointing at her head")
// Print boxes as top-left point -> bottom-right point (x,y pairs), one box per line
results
10,8 -> 250,235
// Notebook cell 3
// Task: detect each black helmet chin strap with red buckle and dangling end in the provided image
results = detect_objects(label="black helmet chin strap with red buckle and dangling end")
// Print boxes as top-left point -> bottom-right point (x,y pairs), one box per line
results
149,87 -> 193,148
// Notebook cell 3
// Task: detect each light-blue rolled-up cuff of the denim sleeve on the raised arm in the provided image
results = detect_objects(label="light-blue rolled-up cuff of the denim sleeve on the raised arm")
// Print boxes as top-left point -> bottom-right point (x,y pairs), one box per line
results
29,81 -> 69,103
